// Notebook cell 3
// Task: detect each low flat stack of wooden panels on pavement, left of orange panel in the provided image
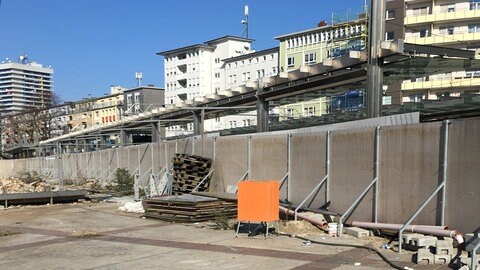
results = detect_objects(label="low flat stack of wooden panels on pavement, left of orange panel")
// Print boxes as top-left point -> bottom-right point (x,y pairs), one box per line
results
142,194 -> 237,223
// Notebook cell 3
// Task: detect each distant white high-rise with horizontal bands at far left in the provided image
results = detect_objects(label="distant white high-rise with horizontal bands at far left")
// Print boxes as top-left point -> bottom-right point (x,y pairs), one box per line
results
0,56 -> 53,113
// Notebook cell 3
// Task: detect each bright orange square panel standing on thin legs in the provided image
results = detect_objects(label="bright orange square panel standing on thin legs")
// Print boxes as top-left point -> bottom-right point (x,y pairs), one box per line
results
238,180 -> 280,222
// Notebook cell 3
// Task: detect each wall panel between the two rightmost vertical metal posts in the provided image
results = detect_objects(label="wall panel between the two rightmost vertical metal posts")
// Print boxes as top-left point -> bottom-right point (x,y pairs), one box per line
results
379,122 -> 442,224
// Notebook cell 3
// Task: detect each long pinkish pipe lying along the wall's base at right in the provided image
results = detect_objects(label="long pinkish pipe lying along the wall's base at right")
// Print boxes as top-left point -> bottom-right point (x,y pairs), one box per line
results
352,221 -> 464,245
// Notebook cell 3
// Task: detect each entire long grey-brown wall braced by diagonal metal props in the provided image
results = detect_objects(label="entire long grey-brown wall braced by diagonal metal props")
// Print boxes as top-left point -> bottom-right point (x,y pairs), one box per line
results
0,118 -> 480,232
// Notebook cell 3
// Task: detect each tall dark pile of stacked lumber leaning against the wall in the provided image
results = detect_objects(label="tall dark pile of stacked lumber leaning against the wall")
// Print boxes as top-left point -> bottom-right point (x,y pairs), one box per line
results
172,154 -> 212,195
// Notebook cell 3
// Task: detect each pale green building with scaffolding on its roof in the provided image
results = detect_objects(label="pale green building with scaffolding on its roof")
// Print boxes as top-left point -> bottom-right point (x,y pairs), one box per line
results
276,12 -> 367,121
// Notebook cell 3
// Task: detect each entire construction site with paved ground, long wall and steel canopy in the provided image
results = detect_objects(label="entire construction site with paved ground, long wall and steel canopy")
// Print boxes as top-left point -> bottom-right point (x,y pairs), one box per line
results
0,1 -> 480,270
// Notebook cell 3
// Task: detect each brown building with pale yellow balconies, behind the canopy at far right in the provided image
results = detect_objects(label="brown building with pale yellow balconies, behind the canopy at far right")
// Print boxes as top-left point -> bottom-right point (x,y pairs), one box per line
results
385,0 -> 480,103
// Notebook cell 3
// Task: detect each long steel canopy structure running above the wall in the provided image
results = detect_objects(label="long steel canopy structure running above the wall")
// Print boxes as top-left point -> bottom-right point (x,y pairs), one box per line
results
32,40 -> 480,154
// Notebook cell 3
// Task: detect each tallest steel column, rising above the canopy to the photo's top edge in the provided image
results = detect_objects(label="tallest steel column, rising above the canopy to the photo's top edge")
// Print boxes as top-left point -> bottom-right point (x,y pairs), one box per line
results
367,0 -> 385,118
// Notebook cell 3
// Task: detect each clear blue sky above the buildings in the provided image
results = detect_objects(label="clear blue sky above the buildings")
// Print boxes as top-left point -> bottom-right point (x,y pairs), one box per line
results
0,0 -> 364,101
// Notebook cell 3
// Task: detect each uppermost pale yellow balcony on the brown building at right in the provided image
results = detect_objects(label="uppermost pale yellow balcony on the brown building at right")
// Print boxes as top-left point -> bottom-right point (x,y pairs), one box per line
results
405,9 -> 480,25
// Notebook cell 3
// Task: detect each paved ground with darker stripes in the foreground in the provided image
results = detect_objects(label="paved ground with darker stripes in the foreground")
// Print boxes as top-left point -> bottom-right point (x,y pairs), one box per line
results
0,203 -> 454,270
